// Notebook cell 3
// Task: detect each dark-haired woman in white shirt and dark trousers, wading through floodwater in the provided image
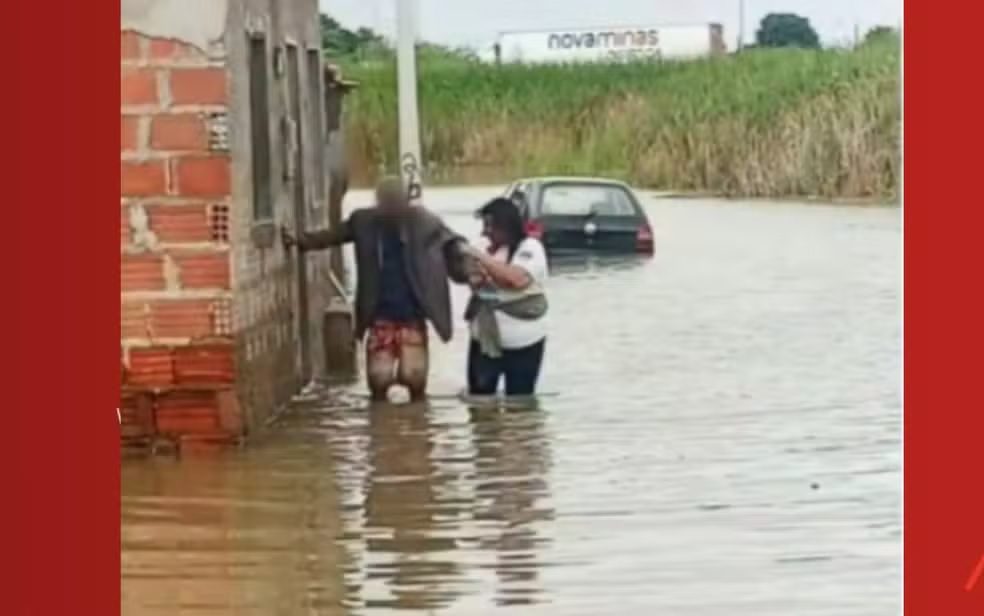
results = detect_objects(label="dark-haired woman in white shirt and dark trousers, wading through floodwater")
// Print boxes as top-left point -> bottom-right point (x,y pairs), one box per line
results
466,198 -> 548,396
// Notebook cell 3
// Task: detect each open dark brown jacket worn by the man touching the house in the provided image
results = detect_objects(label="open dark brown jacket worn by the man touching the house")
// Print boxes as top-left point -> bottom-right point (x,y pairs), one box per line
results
298,206 -> 468,342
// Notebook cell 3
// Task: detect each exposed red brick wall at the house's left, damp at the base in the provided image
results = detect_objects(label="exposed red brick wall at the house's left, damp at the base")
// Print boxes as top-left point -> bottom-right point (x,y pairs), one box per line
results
120,31 -> 242,452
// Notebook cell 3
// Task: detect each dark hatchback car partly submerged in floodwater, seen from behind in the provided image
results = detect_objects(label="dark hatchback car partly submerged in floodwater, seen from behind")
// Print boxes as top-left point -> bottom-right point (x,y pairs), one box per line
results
505,177 -> 653,255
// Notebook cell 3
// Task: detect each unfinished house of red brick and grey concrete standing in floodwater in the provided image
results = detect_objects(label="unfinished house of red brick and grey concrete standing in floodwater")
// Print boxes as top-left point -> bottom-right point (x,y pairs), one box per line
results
120,0 -> 353,447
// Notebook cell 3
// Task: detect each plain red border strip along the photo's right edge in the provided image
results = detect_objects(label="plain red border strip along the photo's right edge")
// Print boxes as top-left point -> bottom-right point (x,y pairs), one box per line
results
904,1 -> 984,616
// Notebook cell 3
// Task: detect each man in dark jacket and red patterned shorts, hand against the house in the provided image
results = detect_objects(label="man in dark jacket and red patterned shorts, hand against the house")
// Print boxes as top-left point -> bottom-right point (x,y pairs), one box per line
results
285,178 -> 468,400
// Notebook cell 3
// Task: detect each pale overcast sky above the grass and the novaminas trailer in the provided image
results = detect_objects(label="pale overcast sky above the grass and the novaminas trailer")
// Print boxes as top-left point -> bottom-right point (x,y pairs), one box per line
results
320,0 -> 902,48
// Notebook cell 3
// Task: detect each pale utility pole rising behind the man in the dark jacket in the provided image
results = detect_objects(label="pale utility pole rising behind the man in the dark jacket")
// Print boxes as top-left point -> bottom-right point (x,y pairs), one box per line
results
394,0 -> 421,198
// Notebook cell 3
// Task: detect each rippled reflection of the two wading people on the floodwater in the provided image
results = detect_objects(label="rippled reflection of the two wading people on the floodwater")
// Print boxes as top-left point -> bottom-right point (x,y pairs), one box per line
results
331,405 -> 549,609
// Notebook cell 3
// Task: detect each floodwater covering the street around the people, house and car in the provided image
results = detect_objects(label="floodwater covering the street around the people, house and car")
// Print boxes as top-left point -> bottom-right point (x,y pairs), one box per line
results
122,188 -> 901,616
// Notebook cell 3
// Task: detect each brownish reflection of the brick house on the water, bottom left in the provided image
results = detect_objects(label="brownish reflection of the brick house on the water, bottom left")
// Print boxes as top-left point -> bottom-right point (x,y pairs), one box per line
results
122,430 -> 346,616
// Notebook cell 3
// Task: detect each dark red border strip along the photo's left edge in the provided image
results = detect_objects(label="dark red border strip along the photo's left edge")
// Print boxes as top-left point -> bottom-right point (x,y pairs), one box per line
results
7,2 -> 120,615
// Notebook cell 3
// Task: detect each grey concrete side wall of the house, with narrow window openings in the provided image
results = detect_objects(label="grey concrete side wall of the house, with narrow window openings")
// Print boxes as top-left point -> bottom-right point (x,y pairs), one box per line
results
226,0 -> 330,424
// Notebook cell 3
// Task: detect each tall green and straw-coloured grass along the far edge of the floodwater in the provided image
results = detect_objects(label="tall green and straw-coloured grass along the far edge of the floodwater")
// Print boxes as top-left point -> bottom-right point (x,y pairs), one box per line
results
338,41 -> 901,199
